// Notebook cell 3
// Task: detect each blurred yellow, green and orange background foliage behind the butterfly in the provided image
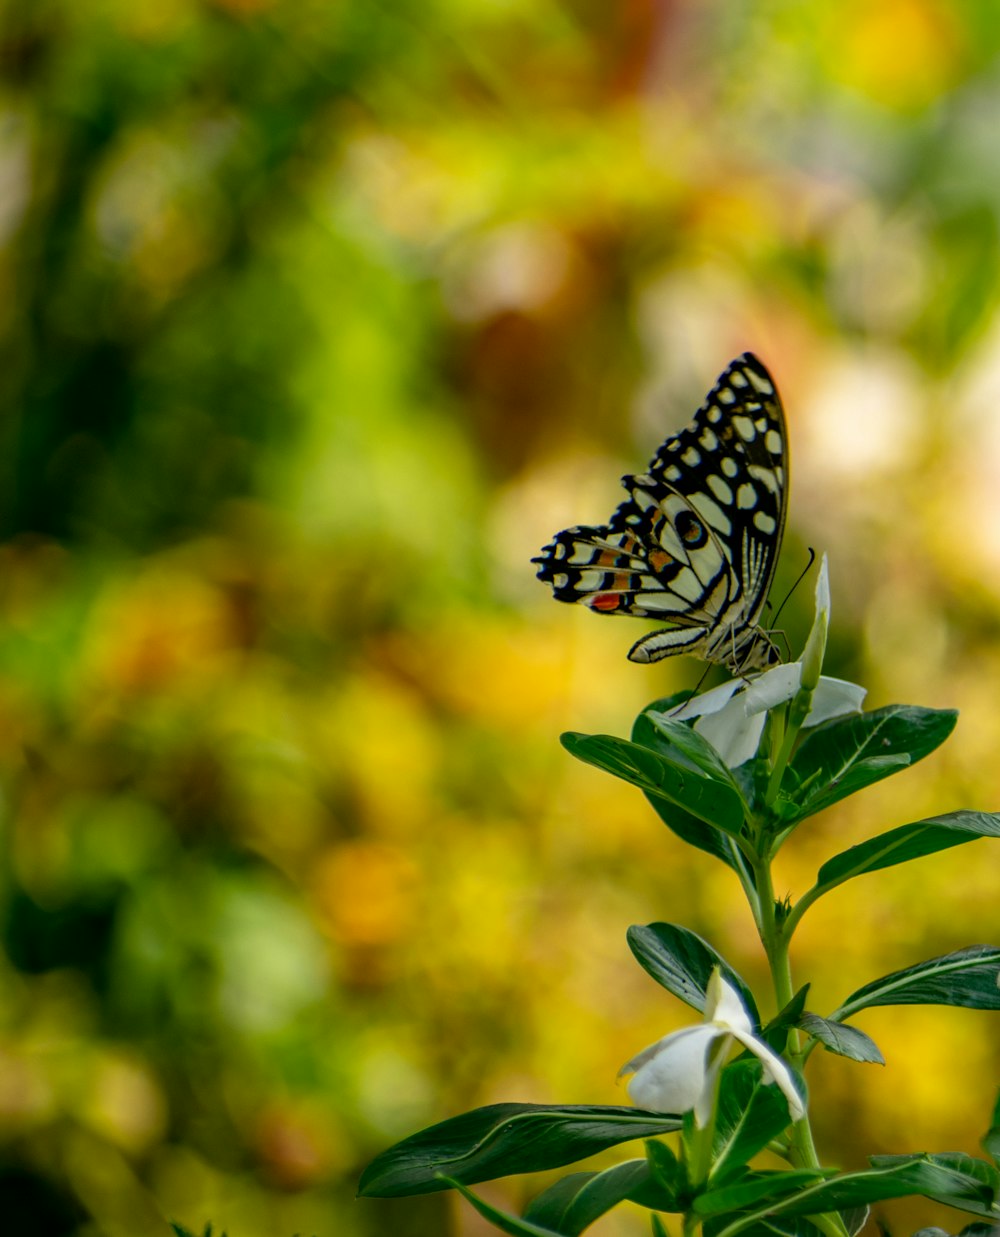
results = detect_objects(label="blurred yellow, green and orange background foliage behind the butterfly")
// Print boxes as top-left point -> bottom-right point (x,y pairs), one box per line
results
0,0 -> 1000,1237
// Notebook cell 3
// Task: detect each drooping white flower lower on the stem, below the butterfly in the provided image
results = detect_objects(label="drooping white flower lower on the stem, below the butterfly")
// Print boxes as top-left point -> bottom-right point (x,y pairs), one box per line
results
619,967 -> 806,1128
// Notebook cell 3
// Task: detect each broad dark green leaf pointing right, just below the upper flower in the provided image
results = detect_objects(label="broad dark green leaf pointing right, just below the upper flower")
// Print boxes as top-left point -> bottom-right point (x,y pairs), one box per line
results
783,704 -> 958,821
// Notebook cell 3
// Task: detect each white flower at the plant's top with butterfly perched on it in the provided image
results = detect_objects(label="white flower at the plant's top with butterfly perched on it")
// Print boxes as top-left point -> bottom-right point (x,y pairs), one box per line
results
670,554 -> 865,768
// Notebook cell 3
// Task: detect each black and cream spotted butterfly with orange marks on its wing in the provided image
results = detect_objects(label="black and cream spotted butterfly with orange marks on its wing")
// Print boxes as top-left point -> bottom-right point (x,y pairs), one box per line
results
532,353 -> 788,674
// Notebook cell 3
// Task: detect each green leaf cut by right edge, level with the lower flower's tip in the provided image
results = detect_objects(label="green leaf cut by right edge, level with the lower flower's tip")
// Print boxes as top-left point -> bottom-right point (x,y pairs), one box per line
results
832,945 -> 1000,1022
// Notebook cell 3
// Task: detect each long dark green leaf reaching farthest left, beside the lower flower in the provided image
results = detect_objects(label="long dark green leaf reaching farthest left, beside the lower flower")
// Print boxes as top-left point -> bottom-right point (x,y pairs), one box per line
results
358,1103 -> 681,1199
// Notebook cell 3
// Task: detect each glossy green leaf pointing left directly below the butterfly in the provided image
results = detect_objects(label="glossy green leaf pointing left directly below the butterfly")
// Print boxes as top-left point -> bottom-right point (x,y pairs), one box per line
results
561,731 -> 744,835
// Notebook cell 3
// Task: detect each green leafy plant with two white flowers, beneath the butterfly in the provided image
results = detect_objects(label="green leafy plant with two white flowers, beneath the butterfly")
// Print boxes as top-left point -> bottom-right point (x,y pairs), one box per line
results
360,559 -> 1000,1237
